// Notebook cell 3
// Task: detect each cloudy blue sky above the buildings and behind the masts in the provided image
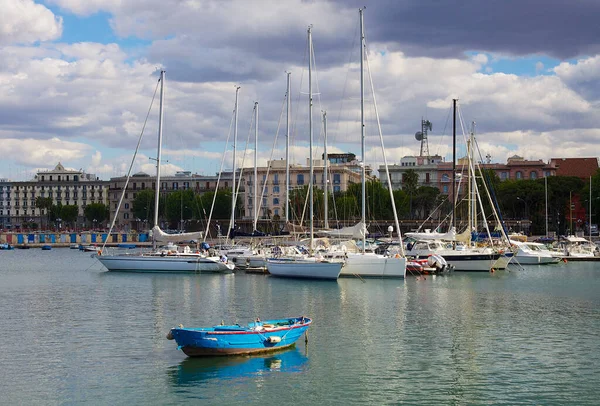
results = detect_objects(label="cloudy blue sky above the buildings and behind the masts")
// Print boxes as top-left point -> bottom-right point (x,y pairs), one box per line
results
0,0 -> 600,181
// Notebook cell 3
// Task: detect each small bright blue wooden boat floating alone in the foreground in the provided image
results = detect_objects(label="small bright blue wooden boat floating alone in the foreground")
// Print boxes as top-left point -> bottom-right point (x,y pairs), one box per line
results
167,316 -> 312,357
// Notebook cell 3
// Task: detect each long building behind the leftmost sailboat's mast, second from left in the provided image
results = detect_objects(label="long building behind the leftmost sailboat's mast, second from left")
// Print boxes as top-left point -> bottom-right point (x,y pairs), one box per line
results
108,171 -> 232,230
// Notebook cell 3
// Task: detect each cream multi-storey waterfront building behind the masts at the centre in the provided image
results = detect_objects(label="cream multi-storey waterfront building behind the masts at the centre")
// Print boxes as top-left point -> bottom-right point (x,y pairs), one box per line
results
242,158 -> 374,219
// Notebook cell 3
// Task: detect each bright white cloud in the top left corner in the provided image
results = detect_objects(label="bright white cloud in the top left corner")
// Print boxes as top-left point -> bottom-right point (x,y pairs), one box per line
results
0,0 -> 62,46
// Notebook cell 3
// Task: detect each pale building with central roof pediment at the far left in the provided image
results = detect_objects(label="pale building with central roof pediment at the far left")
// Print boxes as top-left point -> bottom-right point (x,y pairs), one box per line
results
2,162 -> 108,228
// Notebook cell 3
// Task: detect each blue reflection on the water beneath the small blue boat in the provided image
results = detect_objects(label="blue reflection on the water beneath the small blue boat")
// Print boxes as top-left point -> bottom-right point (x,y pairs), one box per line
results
168,348 -> 308,387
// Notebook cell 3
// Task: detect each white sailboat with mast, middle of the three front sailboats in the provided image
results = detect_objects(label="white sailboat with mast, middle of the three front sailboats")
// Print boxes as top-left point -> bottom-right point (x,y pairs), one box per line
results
267,27 -> 344,280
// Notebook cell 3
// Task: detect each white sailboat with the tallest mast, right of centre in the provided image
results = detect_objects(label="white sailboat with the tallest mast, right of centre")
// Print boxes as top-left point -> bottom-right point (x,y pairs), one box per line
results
340,8 -> 406,278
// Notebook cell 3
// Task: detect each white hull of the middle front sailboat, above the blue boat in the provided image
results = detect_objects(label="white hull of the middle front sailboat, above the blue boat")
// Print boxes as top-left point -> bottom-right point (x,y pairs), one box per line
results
267,259 -> 343,280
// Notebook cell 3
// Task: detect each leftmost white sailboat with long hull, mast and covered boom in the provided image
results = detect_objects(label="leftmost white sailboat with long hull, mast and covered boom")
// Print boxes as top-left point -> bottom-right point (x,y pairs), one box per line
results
97,71 -> 233,273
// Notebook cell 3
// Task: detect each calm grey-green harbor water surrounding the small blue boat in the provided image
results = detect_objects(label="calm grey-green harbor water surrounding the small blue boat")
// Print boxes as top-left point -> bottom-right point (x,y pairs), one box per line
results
0,249 -> 600,405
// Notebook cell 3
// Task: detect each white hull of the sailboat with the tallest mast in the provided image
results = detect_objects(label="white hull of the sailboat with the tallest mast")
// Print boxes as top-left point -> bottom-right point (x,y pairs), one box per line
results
340,253 -> 406,278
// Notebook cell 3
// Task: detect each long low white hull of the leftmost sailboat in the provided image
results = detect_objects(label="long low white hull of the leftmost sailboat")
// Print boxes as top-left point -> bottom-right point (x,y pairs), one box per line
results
97,255 -> 232,273
